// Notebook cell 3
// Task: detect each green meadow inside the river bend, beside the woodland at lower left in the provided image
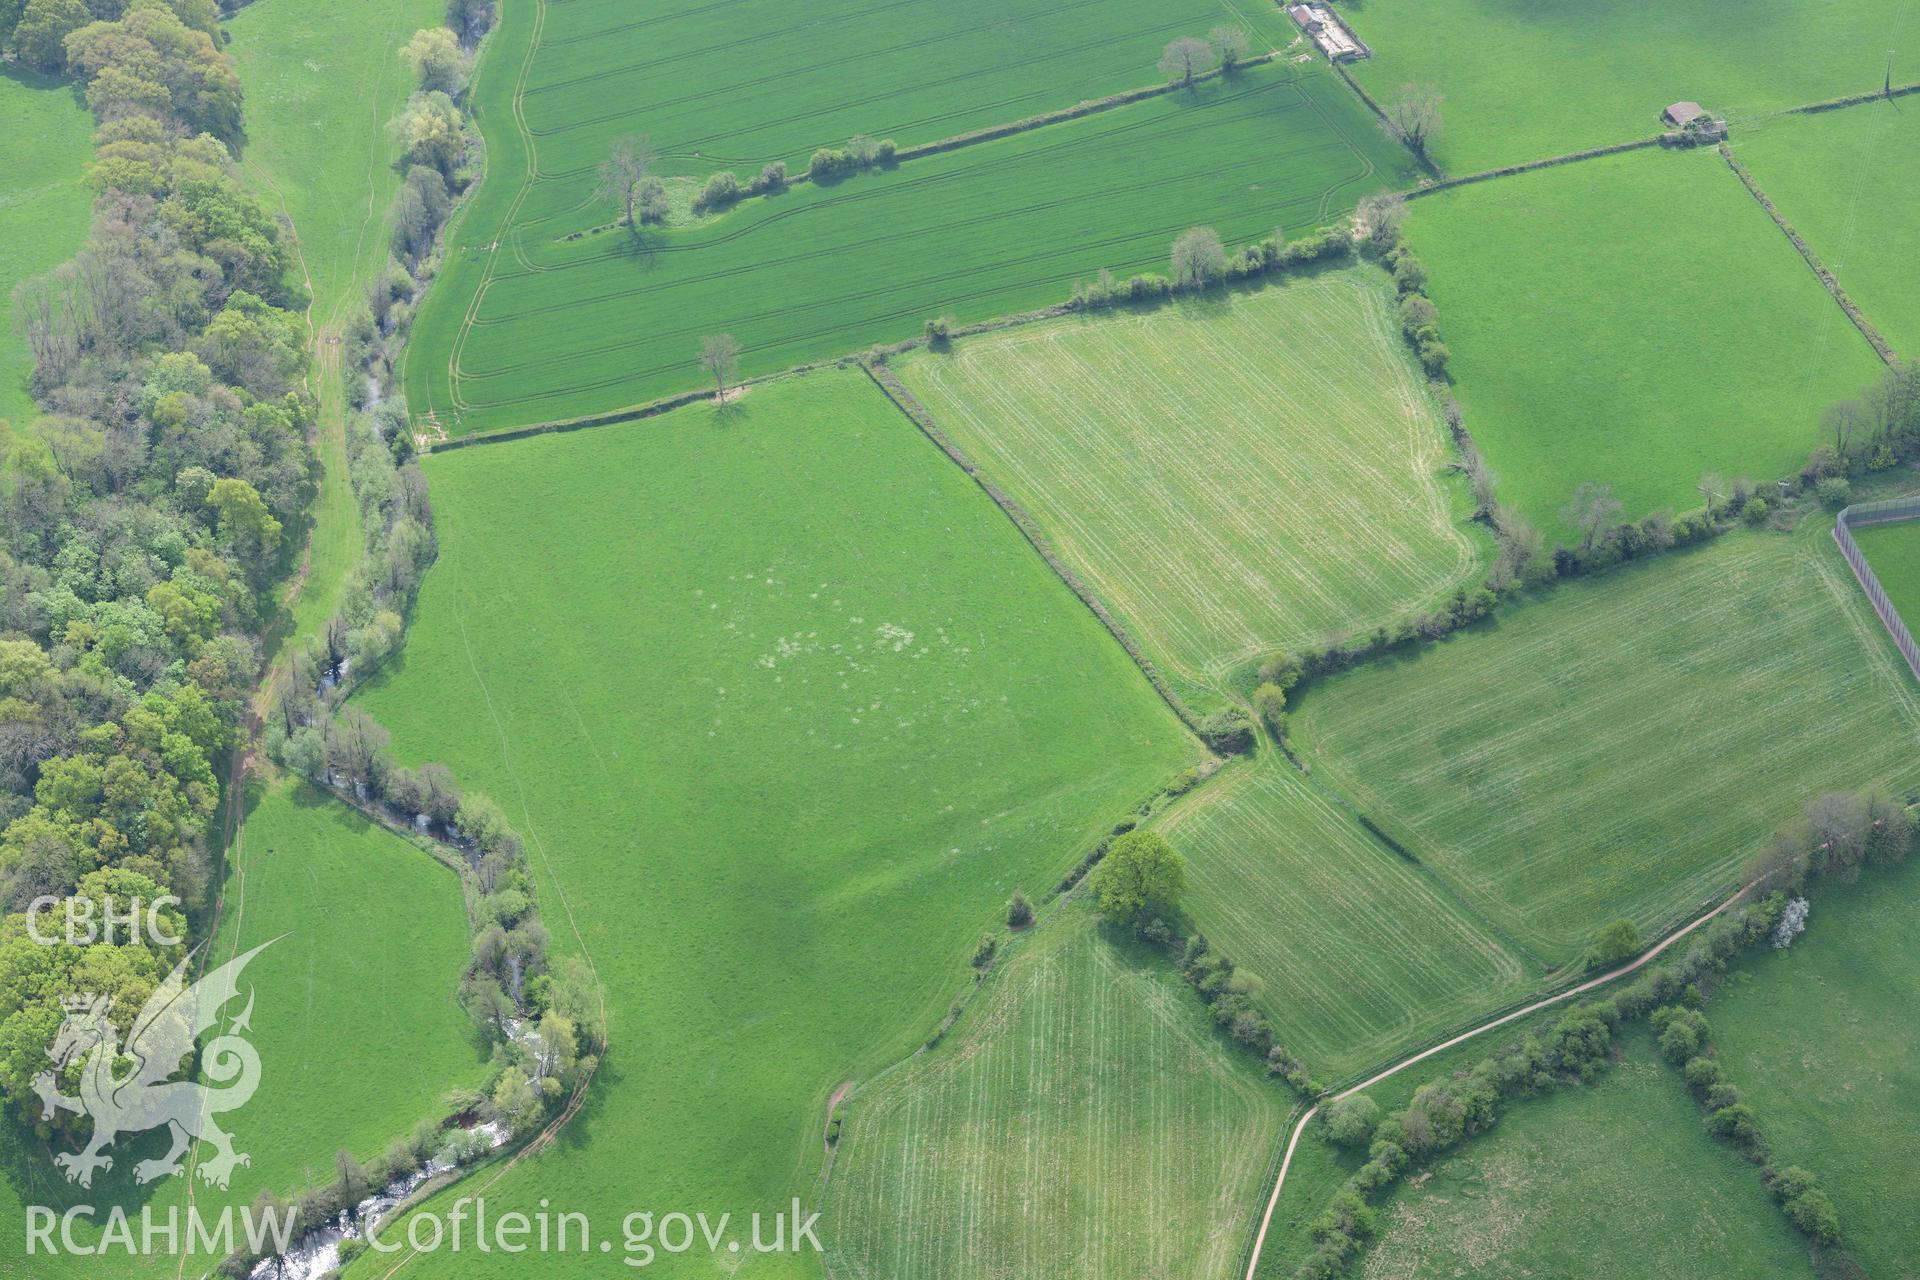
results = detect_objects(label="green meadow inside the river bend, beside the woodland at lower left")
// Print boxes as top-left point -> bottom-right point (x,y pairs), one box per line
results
0,779 -> 488,1276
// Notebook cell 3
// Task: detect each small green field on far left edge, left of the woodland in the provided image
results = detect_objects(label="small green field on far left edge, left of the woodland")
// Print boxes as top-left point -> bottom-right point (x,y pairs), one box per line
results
0,63 -> 94,428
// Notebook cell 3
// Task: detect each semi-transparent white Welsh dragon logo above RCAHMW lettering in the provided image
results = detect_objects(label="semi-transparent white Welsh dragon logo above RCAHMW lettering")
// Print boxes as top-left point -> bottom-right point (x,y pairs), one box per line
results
33,938 -> 278,1188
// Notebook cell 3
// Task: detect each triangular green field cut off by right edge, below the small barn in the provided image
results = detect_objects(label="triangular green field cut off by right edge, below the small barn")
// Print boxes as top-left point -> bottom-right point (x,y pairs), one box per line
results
1734,98 -> 1920,359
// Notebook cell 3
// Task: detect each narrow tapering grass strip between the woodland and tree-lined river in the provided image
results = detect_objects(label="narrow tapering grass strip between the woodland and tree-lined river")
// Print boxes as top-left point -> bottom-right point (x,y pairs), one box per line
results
227,0 -> 444,635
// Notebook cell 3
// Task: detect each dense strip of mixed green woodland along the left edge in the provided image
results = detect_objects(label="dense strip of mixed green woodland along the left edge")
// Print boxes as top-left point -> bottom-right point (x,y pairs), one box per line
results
0,0 -> 315,1123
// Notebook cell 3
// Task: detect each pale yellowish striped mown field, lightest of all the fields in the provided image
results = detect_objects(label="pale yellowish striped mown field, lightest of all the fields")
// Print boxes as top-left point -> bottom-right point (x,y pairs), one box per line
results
899,269 -> 1484,683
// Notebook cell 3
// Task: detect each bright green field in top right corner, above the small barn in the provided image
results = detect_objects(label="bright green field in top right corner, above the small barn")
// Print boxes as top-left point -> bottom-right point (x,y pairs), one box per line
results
1342,0 -> 1920,175
